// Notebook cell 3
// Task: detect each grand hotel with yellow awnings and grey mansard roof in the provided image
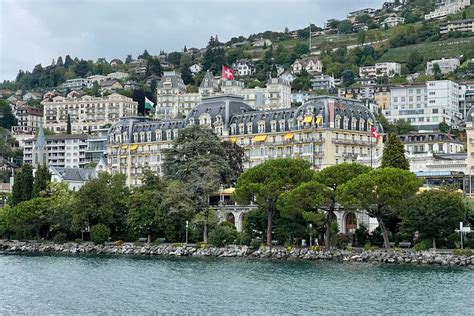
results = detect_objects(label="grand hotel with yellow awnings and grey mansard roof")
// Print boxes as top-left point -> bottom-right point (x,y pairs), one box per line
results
107,95 -> 382,186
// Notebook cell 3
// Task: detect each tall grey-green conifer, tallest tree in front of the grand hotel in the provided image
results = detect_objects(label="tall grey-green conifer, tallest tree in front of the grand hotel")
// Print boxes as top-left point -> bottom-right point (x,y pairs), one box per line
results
163,125 -> 229,243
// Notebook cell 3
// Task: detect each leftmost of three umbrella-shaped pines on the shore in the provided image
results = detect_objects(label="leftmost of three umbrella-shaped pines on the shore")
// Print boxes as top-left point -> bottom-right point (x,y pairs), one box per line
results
235,158 -> 312,246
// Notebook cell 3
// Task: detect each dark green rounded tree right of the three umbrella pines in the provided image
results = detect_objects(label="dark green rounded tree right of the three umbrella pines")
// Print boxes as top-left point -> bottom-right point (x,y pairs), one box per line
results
400,189 -> 468,248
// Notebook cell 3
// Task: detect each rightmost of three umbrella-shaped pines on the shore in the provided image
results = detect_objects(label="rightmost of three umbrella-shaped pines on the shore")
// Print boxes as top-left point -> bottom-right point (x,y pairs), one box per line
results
337,168 -> 422,248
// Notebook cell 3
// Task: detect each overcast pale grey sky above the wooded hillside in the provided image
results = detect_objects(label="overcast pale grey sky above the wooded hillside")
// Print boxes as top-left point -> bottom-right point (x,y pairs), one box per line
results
0,0 -> 384,81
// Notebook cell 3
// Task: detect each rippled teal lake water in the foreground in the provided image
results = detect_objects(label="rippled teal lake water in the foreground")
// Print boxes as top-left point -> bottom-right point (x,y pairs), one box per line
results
0,254 -> 474,315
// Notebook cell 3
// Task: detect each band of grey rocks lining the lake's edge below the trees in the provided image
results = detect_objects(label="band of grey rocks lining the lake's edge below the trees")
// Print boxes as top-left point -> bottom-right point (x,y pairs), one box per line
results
0,241 -> 474,267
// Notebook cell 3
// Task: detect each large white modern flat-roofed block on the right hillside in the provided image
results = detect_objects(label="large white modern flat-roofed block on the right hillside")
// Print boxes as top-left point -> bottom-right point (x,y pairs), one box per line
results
383,80 -> 462,131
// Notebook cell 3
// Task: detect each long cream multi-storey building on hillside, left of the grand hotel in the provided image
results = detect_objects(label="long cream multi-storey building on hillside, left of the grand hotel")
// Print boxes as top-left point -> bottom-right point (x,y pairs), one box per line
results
41,93 -> 138,134
